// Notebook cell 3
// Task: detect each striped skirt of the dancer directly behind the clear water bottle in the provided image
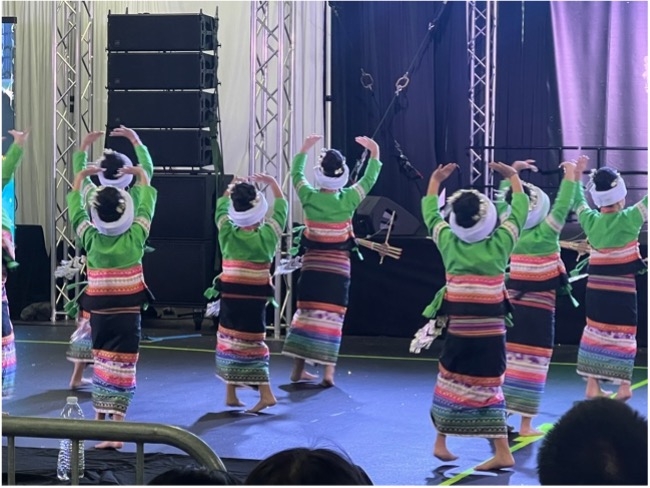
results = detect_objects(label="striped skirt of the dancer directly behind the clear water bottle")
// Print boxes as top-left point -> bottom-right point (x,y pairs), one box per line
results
90,312 -> 140,415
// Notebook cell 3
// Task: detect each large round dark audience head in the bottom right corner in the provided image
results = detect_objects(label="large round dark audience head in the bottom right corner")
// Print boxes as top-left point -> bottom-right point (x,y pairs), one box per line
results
537,398 -> 648,486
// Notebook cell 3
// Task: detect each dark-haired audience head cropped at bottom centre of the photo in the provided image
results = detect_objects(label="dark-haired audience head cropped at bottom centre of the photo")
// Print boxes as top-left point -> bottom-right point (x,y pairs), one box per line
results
245,448 -> 372,485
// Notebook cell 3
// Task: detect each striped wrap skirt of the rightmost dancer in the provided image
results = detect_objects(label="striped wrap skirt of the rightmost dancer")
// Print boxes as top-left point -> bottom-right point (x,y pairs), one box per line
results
577,274 -> 637,384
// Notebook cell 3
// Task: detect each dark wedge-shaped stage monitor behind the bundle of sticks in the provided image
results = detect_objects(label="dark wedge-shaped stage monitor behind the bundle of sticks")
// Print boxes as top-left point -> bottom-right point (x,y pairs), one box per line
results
352,196 -> 425,238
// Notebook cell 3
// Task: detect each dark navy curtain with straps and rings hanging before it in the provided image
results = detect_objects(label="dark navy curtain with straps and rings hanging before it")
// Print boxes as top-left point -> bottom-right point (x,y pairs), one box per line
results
330,2 -> 470,218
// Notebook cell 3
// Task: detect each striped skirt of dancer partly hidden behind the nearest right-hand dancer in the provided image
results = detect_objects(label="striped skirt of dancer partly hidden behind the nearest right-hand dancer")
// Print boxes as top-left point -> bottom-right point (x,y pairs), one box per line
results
503,290 -> 556,417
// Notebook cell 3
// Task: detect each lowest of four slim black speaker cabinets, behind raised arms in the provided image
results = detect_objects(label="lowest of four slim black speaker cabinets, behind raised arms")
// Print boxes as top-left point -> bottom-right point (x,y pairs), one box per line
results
104,127 -> 214,168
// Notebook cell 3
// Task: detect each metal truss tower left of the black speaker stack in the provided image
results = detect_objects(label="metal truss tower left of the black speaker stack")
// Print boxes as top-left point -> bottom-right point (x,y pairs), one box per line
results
50,1 -> 93,322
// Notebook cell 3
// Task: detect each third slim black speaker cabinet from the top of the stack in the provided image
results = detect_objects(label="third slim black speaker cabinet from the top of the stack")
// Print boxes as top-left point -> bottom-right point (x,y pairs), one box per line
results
106,90 -> 215,129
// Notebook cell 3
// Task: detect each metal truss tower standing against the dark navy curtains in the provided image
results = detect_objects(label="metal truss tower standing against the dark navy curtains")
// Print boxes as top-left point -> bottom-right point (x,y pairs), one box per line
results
465,0 -> 498,196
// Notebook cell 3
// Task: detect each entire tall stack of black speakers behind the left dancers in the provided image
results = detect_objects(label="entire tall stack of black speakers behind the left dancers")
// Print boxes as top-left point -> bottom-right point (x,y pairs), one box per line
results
106,12 -> 223,325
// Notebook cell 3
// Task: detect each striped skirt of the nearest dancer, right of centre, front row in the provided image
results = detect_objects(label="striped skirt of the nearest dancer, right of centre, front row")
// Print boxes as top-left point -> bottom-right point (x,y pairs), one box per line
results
430,316 -> 507,438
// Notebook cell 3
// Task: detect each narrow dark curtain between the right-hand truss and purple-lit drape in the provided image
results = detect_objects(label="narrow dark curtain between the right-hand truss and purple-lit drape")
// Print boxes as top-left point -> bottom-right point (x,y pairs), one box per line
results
495,2 -> 562,200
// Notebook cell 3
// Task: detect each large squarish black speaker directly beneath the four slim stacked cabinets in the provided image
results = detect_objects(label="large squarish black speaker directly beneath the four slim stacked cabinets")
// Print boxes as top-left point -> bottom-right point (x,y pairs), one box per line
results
149,173 -> 217,240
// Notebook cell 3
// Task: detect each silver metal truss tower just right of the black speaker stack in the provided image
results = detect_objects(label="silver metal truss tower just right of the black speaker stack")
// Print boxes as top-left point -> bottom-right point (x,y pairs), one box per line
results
249,1 -> 295,339
